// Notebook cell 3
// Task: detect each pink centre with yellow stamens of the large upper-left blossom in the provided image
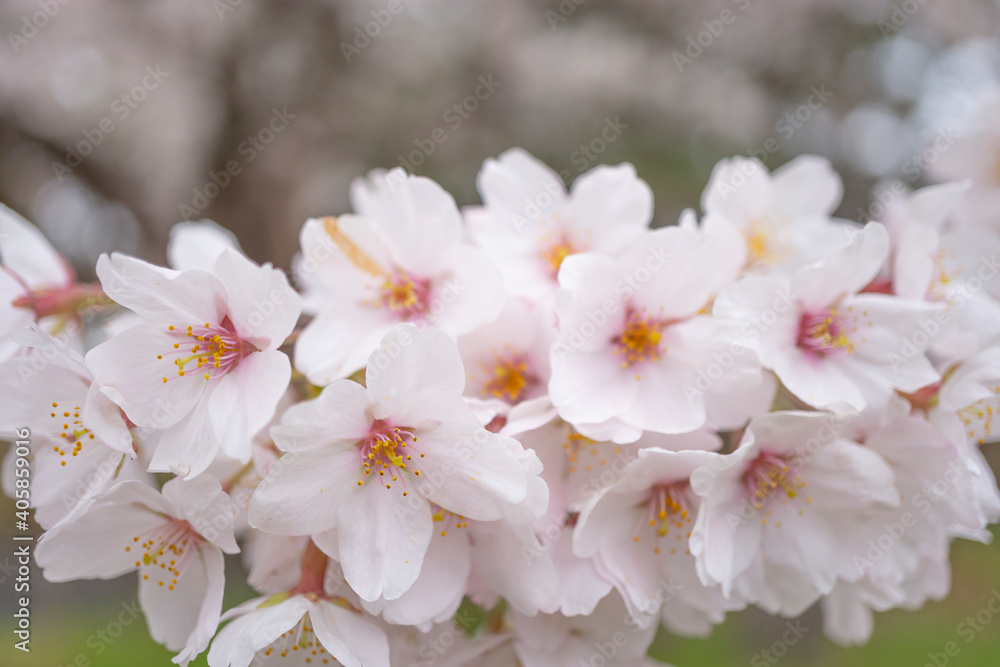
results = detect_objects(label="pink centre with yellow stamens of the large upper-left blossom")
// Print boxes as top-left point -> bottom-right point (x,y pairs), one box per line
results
156,317 -> 257,383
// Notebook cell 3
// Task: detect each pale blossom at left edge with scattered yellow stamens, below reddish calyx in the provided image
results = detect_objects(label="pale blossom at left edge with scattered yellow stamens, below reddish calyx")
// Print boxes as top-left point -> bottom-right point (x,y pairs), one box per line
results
0,325 -> 142,528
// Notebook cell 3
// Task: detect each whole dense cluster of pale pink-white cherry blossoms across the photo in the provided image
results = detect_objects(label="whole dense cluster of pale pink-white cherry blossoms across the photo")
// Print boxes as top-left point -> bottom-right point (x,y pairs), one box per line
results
0,142 -> 1000,667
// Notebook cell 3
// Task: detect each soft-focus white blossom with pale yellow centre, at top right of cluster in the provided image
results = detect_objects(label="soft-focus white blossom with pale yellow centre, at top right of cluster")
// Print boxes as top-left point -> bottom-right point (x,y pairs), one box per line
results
701,155 -> 847,274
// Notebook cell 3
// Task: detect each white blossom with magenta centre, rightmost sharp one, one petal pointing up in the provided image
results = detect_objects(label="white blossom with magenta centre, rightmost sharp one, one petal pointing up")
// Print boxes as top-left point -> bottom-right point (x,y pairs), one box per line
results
712,223 -> 943,410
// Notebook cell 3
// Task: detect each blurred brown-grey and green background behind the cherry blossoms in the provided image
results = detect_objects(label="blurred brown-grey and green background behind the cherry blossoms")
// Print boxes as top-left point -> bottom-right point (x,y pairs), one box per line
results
0,0 -> 1000,667
